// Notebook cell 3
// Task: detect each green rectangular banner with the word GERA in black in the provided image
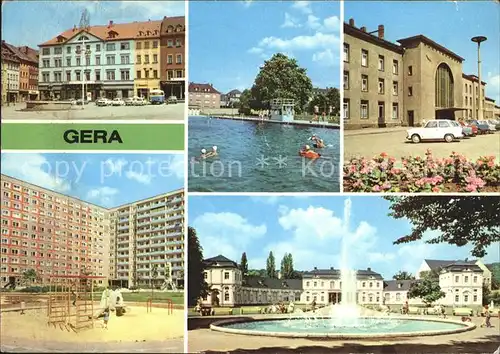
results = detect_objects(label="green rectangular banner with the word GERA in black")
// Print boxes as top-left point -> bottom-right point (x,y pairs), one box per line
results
1,123 -> 185,151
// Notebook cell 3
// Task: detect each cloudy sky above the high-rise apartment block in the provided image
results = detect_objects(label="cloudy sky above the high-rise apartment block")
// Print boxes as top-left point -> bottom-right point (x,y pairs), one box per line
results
1,153 -> 184,208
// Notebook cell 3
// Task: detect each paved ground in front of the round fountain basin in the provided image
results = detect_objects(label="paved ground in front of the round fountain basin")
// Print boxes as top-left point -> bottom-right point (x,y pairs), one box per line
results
188,317 -> 500,354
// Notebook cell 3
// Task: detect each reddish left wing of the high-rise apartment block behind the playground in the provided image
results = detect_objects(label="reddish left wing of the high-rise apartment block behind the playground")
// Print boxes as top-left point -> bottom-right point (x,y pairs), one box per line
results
0,174 -> 109,287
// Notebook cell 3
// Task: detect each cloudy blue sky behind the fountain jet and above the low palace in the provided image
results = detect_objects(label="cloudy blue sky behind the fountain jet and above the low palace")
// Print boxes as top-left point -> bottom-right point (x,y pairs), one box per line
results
189,196 -> 500,279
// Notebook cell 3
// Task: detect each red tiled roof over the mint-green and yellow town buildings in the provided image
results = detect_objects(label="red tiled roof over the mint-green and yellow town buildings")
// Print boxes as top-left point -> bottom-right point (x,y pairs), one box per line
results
39,21 -> 162,47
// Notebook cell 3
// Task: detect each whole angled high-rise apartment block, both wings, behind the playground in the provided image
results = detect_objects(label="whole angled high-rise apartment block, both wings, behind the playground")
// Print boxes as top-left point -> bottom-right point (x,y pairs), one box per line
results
0,174 -> 184,287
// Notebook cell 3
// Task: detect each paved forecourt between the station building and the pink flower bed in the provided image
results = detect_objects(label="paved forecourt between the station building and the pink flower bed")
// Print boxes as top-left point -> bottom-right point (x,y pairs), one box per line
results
344,127 -> 500,163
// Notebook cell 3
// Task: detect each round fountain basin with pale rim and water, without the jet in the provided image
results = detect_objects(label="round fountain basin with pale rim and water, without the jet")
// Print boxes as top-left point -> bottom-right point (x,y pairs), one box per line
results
210,316 -> 476,339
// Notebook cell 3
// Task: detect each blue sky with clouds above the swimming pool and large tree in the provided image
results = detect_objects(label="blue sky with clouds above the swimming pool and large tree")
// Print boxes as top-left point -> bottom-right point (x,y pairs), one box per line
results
189,1 -> 340,93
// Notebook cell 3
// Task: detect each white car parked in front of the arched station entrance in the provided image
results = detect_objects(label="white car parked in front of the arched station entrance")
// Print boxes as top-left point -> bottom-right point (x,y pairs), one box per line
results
406,119 -> 464,143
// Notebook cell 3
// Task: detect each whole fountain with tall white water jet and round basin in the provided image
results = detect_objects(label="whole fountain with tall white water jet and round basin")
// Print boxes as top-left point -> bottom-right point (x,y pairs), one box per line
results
210,199 -> 476,339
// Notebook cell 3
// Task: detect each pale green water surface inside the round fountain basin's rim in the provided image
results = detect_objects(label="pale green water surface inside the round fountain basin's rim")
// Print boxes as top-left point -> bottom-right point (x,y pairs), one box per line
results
223,318 -> 464,335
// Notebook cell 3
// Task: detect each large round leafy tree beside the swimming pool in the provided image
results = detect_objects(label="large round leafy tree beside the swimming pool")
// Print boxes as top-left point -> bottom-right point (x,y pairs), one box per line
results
252,53 -> 312,113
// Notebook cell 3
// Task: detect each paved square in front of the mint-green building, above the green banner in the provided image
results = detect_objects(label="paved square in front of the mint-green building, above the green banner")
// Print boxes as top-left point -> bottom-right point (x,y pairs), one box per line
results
2,103 -> 185,121
